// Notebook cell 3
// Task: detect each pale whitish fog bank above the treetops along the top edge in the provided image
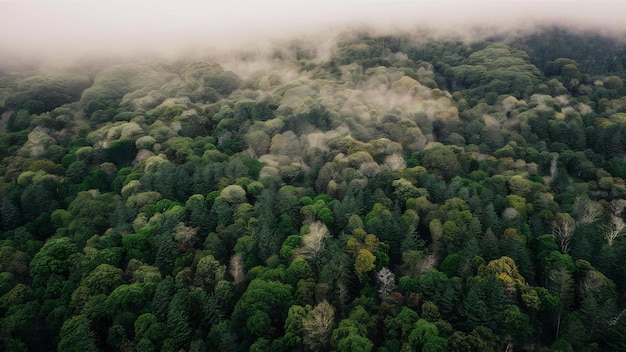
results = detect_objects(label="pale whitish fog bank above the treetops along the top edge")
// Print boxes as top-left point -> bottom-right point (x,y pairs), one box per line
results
0,0 -> 626,66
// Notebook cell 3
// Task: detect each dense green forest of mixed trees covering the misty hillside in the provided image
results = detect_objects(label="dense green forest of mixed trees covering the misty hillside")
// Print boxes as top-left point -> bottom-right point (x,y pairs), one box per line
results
0,27 -> 626,352
